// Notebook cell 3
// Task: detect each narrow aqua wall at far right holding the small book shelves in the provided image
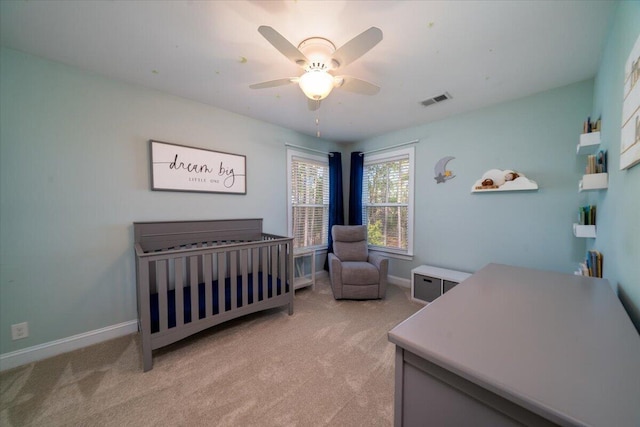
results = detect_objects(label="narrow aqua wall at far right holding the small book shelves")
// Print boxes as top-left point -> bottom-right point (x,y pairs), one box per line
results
590,2 -> 640,330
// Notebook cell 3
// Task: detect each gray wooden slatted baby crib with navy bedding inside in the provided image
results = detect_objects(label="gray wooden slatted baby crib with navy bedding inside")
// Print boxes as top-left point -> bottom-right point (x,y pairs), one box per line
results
133,219 -> 293,372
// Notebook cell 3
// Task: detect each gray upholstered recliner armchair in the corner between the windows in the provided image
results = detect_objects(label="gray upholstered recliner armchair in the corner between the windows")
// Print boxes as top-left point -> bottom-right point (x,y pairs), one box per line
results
328,225 -> 389,299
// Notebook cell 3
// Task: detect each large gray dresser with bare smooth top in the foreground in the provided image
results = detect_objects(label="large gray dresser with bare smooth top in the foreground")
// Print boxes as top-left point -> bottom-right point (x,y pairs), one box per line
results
389,264 -> 640,427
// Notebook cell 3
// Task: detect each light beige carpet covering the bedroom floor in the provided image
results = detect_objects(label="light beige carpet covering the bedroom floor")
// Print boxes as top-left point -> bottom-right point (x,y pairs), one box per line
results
0,278 -> 422,426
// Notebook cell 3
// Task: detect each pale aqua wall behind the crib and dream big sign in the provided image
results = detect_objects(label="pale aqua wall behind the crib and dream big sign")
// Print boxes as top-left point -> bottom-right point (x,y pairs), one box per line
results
0,49 -> 337,354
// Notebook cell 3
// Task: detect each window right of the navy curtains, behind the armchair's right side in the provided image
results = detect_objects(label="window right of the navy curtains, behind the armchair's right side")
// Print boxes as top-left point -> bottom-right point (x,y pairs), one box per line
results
362,147 -> 414,255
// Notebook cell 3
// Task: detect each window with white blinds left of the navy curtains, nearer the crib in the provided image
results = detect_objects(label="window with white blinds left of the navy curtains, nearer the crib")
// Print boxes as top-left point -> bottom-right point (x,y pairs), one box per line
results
287,150 -> 329,249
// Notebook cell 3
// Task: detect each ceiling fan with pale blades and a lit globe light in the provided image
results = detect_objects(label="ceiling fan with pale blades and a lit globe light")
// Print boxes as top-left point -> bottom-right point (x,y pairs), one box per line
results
249,25 -> 382,111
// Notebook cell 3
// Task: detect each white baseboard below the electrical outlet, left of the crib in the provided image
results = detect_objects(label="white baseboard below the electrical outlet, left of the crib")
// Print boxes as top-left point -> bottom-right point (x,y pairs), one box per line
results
0,320 -> 138,371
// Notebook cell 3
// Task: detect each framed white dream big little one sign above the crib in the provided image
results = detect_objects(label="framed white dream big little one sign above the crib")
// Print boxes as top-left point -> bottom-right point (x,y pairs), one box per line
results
149,140 -> 247,194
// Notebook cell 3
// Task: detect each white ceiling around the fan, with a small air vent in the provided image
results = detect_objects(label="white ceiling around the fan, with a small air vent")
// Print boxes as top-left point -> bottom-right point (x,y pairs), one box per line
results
0,0 -> 616,142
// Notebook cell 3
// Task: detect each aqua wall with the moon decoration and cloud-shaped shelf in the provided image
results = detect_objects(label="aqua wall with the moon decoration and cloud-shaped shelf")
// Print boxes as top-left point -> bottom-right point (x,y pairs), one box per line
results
350,80 -> 593,278
